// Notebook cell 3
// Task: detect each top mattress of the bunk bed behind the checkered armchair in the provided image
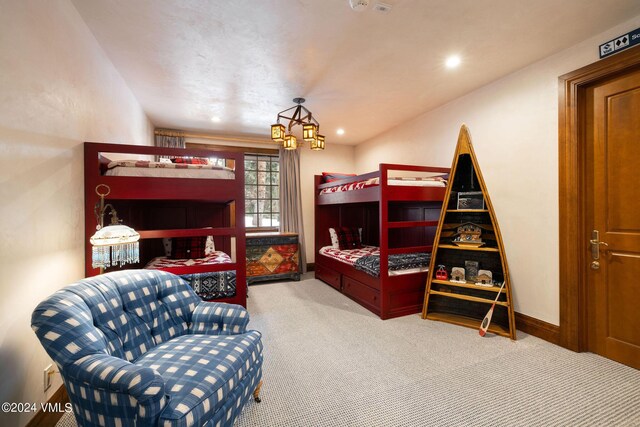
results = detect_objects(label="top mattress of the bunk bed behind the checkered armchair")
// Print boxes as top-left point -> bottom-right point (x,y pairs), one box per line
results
105,160 -> 235,179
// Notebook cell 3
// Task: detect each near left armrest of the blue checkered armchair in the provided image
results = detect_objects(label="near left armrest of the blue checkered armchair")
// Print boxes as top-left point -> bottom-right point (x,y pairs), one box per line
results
62,353 -> 167,426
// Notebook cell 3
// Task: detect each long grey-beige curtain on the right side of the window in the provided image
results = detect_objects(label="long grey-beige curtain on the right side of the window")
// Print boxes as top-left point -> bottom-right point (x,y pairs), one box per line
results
279,147 -> 307,273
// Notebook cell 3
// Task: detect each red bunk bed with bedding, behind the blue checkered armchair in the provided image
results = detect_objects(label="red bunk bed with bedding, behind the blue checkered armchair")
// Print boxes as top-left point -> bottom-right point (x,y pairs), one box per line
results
84,142 -> 247,306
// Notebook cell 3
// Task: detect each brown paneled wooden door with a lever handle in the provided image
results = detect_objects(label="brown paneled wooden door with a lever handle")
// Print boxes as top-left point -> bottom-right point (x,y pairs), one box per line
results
584,70 -> 640,369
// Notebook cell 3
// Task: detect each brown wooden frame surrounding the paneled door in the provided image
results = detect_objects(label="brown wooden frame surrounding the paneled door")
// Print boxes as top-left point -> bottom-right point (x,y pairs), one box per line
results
558,45 -> 640,351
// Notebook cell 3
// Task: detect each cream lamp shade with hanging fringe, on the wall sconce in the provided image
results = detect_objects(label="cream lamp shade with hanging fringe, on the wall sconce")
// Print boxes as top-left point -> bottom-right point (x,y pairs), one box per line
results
89,224 -> 140,268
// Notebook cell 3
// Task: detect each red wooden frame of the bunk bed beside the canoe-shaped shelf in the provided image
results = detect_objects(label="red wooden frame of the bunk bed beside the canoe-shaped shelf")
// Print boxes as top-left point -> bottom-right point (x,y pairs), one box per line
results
315,164 -> 449,319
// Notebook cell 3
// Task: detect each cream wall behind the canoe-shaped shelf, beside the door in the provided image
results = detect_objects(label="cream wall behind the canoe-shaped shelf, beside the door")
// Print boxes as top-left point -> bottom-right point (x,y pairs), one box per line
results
355,16 -> 640,325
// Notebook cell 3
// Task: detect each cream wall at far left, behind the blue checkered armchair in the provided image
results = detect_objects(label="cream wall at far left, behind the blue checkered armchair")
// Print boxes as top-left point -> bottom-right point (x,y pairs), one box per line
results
0,0 -> 152,426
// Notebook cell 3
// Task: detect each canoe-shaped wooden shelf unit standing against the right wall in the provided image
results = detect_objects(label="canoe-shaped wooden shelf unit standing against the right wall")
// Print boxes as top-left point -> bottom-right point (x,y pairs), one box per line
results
422,125 -> 516,340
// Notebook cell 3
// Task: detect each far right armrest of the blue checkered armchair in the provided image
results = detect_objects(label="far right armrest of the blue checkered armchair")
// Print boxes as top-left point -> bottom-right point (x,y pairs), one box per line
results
189,301 -> 249,335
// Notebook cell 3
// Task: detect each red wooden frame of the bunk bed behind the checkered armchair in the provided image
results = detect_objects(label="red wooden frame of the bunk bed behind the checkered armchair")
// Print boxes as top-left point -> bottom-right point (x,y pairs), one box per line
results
84,142 -> 247,307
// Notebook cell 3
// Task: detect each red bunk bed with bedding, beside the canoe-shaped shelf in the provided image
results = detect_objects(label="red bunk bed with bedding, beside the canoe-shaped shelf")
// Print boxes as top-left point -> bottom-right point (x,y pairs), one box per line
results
314,164 -> 449,319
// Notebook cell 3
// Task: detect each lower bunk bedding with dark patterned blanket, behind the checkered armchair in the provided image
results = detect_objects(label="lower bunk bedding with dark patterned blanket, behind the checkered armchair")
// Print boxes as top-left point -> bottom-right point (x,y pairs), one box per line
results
145,251 -> 236,300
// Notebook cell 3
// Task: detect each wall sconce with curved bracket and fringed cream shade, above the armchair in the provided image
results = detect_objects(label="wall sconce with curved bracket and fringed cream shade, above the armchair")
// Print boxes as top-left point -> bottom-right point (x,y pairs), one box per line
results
89,184 -> 140,269
